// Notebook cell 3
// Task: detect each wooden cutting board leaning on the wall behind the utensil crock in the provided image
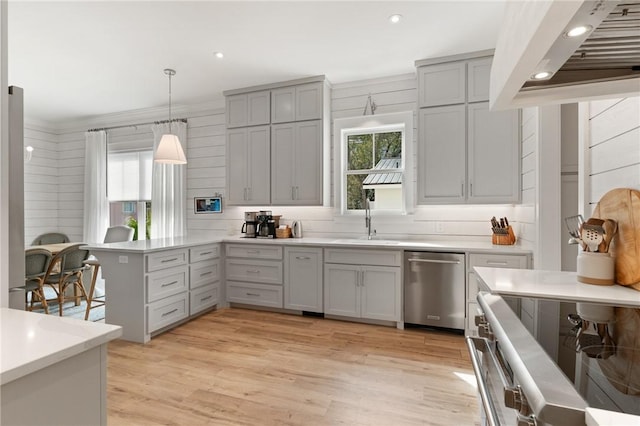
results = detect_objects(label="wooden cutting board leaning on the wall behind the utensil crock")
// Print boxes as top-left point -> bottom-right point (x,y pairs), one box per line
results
593,188 -> 640,291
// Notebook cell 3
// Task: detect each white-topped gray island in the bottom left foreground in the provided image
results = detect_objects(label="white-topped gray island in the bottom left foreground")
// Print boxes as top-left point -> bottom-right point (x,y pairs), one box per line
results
0,308 -> 122,425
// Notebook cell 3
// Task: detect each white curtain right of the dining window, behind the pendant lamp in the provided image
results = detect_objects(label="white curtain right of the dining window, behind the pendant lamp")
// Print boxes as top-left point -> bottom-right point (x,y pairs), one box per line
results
151,121 -> 187,238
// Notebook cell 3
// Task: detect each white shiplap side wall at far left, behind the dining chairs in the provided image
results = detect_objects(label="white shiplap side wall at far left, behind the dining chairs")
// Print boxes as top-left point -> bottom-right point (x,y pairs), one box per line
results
24,123 -> 59,244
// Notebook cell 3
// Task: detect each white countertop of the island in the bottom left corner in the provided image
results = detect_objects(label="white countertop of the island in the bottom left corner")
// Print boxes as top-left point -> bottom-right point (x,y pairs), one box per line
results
0,308 -> 122,386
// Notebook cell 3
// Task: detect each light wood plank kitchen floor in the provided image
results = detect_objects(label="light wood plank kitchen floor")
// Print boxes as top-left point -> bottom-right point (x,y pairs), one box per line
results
107,308 -> 478,426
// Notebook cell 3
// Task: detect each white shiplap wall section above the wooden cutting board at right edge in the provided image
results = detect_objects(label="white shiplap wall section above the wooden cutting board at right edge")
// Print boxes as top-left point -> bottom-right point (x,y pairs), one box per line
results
583,97 -> 640,211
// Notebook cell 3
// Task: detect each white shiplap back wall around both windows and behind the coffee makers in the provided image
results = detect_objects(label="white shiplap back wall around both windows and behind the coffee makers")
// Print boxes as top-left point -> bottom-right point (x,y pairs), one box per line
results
27,74 -> 527,241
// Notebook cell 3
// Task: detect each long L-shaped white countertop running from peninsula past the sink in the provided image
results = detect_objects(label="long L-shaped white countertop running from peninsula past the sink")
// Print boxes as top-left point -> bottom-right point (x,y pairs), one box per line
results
87,236 -> 531,254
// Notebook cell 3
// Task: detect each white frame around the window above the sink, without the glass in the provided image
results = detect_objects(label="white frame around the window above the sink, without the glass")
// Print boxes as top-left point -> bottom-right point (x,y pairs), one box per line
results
333,111 -> 416,217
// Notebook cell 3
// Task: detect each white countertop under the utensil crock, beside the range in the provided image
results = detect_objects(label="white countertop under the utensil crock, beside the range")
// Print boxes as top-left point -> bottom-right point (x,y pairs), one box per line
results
474,266 -> 640,308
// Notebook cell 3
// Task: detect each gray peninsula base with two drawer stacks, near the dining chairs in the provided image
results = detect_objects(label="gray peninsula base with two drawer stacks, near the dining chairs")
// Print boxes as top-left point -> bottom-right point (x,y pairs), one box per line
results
92,244 -> 220,343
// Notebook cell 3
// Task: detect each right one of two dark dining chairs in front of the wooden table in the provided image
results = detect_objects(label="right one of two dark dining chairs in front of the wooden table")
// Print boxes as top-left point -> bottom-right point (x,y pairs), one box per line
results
43,243 -> 89,316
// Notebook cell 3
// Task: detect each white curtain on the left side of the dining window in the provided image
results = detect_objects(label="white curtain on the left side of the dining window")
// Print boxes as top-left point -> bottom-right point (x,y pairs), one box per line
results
83,130 -> 109,244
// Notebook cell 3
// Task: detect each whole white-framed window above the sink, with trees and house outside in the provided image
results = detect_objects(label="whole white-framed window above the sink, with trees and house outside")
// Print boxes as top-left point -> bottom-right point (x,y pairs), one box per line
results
334,112 -> 413,215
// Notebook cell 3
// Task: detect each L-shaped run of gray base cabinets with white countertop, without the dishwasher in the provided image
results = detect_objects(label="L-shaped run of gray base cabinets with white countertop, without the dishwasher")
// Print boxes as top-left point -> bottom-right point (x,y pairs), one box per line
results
88,236 -> 531,343
